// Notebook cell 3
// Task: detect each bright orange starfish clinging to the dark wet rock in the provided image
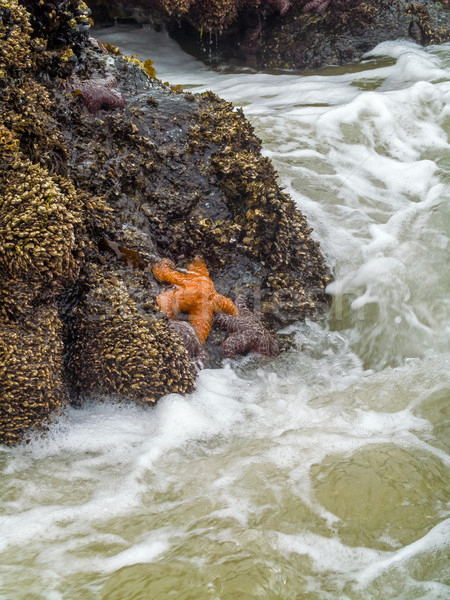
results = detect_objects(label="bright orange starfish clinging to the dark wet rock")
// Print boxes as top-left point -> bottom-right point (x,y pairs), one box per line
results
153,256 -> 239,344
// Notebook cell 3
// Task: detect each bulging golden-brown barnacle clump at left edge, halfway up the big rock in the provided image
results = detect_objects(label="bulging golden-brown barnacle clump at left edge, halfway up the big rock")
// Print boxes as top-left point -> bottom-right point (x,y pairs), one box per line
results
0,131 -> 107,317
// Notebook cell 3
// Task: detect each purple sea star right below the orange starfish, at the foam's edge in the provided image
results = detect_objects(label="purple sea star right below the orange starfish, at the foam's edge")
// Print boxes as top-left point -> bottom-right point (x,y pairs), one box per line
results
215,296 -> 279,358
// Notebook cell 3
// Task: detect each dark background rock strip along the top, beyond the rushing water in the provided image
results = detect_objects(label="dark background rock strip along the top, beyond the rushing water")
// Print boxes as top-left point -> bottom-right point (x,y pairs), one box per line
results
88,0 -> 450,71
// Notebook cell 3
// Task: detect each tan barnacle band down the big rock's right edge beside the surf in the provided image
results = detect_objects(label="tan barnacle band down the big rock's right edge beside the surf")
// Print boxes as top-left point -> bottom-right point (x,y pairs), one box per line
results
185,93 -> 329,327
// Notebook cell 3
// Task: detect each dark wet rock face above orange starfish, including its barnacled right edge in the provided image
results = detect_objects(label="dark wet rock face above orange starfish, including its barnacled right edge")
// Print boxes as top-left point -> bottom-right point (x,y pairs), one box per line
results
48,39 -> 329,338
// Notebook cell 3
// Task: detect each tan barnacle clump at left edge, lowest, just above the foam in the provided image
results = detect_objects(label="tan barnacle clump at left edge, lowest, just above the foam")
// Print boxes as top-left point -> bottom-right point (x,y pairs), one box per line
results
0,305 -> 68,445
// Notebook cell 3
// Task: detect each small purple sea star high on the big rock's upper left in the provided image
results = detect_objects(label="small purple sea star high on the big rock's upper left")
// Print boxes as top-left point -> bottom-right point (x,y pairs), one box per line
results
67,75 -> 125,114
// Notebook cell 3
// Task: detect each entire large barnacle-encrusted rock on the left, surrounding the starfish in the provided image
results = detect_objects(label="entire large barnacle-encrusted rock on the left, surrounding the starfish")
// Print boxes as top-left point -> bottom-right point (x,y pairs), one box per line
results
0,0 -> 329,444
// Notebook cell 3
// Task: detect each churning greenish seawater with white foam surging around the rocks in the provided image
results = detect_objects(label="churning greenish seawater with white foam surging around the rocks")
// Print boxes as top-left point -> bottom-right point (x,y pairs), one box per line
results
0,29 -> 450,600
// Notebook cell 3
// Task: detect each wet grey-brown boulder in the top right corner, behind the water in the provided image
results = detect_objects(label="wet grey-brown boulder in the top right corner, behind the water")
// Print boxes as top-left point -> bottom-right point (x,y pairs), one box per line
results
250,0 -> 450,70
